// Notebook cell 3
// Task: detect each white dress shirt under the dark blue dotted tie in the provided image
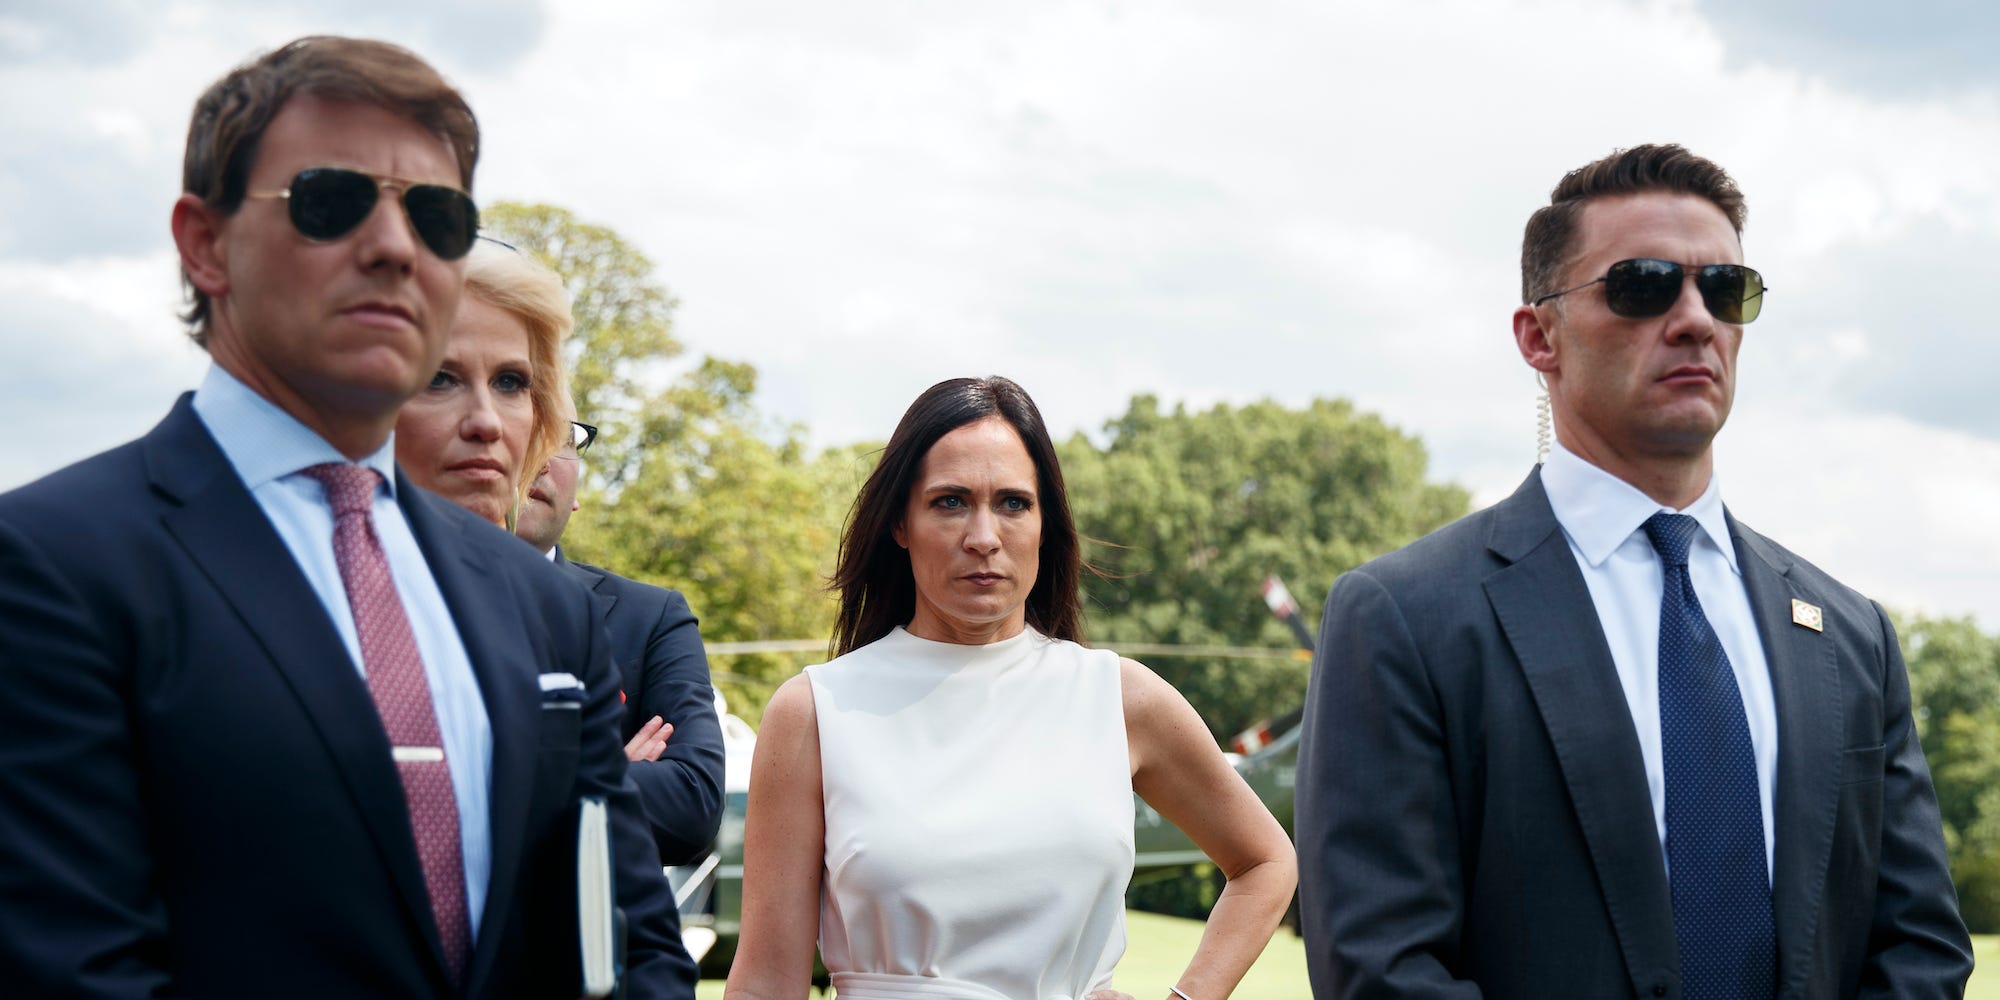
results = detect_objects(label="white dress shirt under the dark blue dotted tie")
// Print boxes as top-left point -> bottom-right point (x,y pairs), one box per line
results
1542,442 -> 1778,876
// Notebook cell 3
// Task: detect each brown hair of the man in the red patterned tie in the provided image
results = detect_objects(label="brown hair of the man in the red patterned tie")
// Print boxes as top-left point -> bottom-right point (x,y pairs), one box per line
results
180,34 -> 480,346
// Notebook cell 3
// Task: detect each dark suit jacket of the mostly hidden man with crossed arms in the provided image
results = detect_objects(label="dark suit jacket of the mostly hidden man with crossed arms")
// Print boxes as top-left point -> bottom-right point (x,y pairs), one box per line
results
556,548 -> 722,864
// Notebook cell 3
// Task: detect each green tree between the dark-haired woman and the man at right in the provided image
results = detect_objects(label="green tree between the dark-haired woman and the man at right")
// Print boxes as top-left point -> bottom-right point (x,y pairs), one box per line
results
1060,396 -> 1468,738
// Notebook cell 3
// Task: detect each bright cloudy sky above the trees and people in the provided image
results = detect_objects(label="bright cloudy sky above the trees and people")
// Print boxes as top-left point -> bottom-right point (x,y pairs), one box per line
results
0,0 -> 2000,628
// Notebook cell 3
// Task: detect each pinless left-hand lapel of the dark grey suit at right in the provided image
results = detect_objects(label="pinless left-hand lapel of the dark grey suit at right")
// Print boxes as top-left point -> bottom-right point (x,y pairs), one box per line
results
1486,470 -> 1678,976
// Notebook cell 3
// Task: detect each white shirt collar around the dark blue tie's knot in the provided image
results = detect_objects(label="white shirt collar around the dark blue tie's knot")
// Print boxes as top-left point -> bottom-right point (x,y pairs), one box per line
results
1542,440 -> 1742,574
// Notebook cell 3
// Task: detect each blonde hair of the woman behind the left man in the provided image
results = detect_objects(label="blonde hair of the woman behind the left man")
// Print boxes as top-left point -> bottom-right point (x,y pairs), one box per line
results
466,240 -> 576,504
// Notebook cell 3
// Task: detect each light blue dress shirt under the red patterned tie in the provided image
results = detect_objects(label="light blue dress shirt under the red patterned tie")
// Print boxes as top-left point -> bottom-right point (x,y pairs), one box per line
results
194,366 -> 494,940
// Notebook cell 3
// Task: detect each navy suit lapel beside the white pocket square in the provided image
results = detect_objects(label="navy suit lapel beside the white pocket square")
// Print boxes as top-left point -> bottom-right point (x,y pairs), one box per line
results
396,482 -> 540,994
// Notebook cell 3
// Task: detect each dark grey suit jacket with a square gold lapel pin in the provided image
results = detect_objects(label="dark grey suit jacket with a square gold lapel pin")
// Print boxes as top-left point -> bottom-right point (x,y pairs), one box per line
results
1296,472 -> 1972,1000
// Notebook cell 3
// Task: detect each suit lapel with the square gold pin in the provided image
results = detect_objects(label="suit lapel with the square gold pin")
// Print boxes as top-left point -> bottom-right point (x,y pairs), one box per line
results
1730,516 -> 1842,996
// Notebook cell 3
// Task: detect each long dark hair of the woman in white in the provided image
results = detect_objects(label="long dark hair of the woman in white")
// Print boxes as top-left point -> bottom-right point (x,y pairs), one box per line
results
832,376 -> 1084,656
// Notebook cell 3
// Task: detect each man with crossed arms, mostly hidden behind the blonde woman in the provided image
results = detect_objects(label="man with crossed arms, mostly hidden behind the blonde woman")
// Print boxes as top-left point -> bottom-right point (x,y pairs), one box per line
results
514,410 -> 722,864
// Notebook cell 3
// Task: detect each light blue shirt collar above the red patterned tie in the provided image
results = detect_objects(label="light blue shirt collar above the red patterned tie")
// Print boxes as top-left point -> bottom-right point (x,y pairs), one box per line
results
194,364 -> 396,500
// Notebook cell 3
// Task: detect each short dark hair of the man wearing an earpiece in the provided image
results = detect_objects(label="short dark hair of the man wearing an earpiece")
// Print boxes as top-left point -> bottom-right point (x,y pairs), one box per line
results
1520,142 -> 1748,302
